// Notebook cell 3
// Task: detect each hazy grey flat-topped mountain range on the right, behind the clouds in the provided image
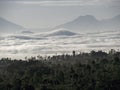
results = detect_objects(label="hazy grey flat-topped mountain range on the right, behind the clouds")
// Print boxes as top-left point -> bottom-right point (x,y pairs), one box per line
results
55,15 -> 120,32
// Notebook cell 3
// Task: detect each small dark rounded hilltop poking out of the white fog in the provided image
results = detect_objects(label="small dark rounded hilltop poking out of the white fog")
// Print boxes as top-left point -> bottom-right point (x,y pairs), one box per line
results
45,28 -> 77,36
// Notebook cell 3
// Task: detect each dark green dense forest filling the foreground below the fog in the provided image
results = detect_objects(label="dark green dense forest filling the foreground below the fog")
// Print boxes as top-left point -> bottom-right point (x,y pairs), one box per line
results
0,50 -> 120,90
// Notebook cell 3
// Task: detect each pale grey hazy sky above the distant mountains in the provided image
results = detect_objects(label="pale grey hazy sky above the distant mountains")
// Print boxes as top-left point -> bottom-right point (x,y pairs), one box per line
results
0,0 -> 120,28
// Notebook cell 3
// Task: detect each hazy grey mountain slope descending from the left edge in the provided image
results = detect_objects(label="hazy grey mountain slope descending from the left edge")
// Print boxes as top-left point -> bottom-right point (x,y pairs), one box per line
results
0,17 -> 24,33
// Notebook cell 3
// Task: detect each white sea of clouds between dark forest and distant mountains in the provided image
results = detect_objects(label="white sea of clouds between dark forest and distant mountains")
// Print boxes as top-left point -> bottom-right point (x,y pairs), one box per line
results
0,31 -> 120,58
